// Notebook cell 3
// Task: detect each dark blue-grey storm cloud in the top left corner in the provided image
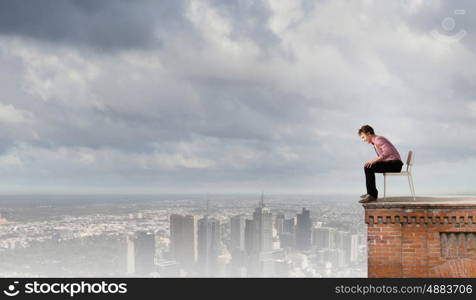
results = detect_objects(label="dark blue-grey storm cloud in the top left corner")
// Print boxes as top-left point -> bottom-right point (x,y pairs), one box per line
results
0,0 -> 186,50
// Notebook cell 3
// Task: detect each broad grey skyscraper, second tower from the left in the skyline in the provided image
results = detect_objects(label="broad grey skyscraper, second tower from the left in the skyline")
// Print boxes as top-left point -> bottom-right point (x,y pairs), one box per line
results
170,214 -> 197,269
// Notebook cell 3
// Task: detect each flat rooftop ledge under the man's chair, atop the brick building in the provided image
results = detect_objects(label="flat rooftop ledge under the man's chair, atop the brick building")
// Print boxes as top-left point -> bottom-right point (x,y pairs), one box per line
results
363,195 -> 476,209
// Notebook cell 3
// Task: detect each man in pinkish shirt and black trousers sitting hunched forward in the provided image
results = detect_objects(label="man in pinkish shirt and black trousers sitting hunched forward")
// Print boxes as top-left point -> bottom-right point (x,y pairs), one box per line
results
358,125 -> 403,203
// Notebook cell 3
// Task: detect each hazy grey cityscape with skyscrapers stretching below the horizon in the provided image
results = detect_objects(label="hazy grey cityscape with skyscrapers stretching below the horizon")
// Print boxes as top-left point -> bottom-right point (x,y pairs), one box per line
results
0,194 -> 367,277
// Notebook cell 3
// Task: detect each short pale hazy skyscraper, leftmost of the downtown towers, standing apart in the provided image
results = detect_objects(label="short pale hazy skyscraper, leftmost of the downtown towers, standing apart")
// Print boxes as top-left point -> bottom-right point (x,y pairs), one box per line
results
127,231 -> 155,276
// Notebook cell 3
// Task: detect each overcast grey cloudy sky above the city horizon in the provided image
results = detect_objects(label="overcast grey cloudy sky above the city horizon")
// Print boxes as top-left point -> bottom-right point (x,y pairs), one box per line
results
0,0 -> 476,195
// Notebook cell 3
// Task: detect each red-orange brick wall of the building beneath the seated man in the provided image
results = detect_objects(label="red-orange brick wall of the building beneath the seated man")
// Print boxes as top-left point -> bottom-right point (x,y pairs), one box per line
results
364,203 -> 476,277
